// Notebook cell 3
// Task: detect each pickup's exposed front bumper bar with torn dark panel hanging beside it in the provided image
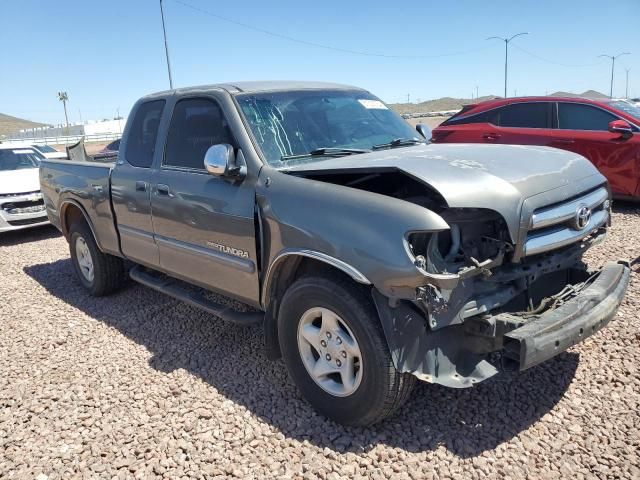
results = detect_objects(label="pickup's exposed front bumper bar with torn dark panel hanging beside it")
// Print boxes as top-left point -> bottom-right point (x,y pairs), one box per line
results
373,262 -> 630,388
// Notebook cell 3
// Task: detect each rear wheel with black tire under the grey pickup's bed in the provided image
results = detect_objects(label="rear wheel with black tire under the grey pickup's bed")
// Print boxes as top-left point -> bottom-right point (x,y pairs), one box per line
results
69,222 -> 125,297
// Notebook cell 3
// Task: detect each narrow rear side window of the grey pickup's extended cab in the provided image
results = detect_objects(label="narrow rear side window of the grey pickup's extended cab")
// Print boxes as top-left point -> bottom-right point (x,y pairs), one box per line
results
125,100 -> 165,168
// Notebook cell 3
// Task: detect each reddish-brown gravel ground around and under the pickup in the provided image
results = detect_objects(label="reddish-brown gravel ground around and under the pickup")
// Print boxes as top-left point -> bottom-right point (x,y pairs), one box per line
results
0,206 -> 640,480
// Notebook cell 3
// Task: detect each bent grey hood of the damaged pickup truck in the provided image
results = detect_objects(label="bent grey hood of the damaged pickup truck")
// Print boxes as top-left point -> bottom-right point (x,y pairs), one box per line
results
288,144 -> 606,240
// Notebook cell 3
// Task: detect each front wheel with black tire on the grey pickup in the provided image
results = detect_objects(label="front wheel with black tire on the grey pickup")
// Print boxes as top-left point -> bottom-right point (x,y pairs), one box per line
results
278,274 -> 416,426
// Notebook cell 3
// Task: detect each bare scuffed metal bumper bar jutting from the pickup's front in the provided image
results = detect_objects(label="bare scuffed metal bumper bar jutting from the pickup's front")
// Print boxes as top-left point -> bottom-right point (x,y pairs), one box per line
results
504,263 -> 630,370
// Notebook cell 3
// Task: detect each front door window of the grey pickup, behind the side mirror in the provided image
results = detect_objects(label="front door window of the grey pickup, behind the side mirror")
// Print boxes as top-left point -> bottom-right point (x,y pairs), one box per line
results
164,98 -> 235,170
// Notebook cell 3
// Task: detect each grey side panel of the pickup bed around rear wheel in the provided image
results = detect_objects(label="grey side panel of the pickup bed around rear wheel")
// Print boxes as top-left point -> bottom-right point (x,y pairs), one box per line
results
40,160 -> 120,255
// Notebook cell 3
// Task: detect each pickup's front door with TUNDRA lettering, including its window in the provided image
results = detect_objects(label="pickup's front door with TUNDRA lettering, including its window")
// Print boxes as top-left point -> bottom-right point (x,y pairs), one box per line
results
151,92 -> 259,305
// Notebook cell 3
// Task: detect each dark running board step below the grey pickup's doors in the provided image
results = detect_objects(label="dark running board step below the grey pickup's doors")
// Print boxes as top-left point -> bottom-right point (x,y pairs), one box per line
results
129,265 -> 264,325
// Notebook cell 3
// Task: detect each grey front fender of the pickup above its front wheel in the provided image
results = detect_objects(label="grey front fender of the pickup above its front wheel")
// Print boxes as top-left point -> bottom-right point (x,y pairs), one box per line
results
256,167 -> 449,298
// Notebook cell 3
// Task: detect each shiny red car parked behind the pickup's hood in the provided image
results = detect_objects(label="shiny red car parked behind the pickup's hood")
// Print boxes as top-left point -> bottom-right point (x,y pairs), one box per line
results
433,97 -> 640,200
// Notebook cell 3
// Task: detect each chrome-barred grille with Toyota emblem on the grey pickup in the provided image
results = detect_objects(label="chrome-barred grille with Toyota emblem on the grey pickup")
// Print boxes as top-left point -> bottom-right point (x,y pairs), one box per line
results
524,187 -> 609,255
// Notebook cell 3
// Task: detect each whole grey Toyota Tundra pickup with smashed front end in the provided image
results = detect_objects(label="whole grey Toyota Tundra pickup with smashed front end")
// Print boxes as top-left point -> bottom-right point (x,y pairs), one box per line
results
40,82 -> 629,425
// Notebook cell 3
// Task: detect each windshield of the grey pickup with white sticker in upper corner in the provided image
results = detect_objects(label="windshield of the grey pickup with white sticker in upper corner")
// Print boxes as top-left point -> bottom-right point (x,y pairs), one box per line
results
237,90 -> 424,167
